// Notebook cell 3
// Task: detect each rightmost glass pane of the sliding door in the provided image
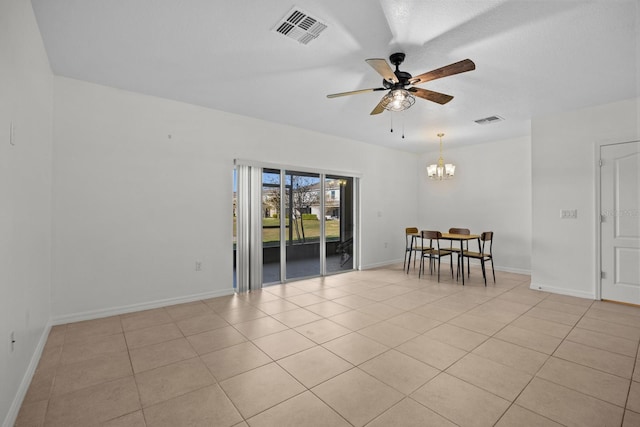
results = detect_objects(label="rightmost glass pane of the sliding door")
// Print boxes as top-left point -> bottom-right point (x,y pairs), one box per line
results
324,175 -> 354,274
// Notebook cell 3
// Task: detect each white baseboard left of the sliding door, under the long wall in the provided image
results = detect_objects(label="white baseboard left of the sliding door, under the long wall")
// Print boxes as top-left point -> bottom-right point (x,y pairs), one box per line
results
51,288 -> 234,325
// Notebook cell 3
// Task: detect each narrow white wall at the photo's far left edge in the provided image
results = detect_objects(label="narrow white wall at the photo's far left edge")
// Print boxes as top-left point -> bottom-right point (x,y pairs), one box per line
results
0,0 -> 53,426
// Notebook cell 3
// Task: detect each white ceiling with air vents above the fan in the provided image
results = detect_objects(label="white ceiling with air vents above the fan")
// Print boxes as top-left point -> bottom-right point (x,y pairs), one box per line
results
32,0 -> 640,152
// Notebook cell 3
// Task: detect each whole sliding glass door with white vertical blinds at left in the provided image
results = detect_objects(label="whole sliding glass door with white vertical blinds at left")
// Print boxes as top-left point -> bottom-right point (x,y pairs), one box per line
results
234,160 -> 357,291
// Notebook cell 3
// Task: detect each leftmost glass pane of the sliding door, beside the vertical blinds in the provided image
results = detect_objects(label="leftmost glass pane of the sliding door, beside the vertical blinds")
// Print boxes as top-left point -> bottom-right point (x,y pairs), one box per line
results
262,169 -> 280,283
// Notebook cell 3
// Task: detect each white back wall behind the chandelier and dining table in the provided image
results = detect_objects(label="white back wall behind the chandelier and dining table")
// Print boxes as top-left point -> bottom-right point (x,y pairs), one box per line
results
416,135 -> 531,273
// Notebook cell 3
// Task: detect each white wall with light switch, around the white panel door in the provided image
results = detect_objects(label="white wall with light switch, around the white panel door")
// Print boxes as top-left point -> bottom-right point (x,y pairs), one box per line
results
531,99 -> 640,298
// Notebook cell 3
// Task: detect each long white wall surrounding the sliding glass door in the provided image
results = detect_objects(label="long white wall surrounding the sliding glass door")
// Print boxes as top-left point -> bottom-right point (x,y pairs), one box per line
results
53,77 -> 418,322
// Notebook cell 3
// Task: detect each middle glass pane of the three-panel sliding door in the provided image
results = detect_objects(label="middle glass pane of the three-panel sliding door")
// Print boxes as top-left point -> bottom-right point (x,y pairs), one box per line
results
285,171 -> 322,279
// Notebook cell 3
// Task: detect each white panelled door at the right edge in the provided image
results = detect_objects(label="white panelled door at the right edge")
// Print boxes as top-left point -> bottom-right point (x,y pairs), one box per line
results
600,141 -> 640,305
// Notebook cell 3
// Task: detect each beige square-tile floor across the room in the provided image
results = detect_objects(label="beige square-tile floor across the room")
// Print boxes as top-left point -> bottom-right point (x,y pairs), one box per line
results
17,266 -> 640,427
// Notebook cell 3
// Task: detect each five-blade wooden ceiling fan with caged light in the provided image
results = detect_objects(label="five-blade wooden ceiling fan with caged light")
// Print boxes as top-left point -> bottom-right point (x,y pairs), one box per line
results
327,52 -> 476,115
